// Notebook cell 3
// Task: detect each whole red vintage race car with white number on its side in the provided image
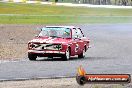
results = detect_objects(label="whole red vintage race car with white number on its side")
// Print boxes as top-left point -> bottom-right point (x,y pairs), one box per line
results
28,26 -> 90,60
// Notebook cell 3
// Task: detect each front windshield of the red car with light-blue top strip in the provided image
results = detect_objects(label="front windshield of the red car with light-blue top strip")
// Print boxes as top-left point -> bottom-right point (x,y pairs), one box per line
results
39,27 -> 71,38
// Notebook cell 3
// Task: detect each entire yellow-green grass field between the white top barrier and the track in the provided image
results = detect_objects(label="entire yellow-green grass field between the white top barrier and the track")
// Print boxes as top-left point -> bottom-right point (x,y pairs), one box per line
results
0,3 -> 132,24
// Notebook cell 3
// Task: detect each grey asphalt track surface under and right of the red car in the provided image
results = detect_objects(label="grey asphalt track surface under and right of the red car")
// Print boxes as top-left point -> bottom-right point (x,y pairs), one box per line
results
0,24 -> 132,81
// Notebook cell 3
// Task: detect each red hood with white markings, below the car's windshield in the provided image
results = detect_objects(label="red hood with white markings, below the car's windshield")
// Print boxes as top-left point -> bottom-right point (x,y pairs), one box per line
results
29,37 -> 71,44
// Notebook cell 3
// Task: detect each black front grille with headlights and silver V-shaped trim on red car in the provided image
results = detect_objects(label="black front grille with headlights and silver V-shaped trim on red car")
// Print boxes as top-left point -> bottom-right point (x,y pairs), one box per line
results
29,43 -> 62,50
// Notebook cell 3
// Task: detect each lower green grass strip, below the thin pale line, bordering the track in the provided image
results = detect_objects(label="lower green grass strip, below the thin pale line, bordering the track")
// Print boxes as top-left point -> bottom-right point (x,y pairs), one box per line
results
0,16 -> 132,24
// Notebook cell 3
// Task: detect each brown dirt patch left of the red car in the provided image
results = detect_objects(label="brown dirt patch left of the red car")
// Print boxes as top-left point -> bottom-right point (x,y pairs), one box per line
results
0,24 -> 43,60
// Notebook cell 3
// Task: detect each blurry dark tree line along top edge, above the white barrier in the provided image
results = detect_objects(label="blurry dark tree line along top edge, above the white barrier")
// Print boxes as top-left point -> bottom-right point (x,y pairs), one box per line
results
43,0 -> 132,6
